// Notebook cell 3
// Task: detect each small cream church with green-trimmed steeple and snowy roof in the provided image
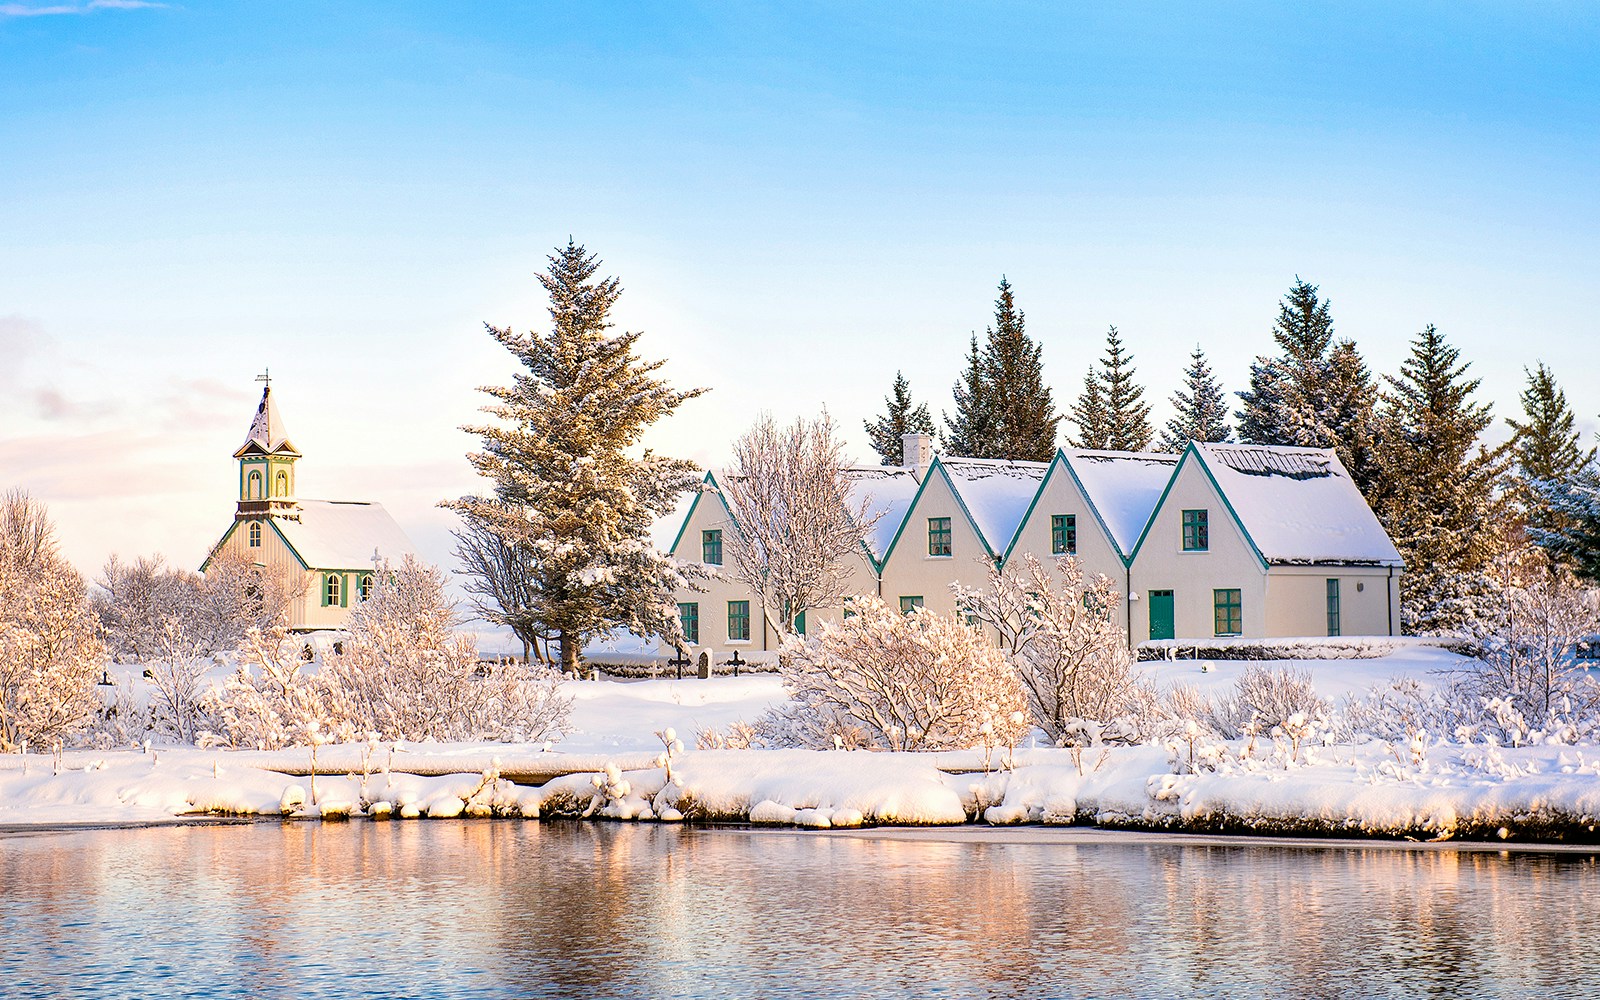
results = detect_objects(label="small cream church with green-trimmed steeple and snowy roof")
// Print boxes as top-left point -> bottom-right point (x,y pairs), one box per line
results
200,382 -> 414,629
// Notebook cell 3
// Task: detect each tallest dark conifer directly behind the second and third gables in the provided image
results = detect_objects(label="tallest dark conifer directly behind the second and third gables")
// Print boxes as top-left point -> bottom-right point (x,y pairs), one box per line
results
973,277 -> 1061,462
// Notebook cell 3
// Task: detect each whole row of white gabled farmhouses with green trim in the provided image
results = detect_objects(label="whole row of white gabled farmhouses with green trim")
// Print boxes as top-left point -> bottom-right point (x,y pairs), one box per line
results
670,435 -> 1402,656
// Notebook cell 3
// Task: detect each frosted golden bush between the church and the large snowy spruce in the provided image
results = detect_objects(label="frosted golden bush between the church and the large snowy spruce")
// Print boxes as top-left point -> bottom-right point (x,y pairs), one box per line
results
322,557 -> 571,741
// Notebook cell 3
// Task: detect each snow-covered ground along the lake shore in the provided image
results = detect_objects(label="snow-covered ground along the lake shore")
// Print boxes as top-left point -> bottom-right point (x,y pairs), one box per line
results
0,648 -> 1600,840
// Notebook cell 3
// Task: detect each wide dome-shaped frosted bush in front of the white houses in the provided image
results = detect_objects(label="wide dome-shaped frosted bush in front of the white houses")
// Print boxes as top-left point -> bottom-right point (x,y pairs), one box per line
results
757,597 -> 1027,750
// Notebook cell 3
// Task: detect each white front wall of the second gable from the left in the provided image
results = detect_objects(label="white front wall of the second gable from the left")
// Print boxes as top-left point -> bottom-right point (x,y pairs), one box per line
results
880,470 -> 992,614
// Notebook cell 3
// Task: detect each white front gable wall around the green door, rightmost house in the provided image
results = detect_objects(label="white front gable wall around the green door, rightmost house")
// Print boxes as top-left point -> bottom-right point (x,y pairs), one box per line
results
1131,459 -> 1267,643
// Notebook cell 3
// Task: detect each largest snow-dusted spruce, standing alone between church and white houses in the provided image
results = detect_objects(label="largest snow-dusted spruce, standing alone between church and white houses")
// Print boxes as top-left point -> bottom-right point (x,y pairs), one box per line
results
445,240 -> 704,674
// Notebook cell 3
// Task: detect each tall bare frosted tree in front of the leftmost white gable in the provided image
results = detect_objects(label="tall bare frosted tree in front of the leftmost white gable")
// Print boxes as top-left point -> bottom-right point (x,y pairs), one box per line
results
720,411 -> 883,635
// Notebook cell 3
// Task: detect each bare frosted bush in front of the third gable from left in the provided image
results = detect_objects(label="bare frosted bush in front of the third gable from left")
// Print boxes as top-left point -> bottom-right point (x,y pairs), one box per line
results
950,555 -> 1152,746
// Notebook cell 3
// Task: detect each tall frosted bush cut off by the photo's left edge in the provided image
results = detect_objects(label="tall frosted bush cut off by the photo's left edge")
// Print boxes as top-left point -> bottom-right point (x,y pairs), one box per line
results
0,490 -> 106,750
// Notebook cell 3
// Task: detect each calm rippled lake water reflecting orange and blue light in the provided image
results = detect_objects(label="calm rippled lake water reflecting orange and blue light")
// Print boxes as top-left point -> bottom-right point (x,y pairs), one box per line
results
0,821 -> 1600,998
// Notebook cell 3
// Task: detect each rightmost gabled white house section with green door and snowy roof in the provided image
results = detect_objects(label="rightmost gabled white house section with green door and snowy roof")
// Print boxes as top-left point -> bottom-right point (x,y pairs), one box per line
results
1130,443 -> 1403,643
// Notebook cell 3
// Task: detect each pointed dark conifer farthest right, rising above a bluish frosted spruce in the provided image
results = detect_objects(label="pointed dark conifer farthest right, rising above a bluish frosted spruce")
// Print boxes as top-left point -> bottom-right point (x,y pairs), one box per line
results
1506,362 -> 1595,562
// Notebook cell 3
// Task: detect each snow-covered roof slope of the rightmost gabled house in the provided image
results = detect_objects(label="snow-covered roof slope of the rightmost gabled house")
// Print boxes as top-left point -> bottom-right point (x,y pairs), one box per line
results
1195,443 -> 1402,566
